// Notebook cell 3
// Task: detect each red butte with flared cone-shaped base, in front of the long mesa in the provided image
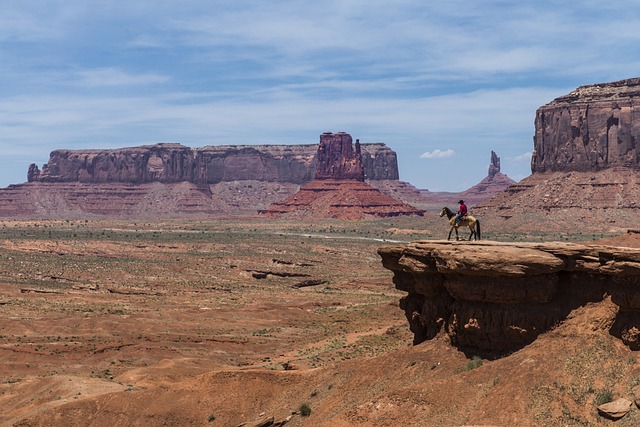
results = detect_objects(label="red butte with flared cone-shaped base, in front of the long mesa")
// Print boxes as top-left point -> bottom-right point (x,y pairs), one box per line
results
260,132 -> 423,220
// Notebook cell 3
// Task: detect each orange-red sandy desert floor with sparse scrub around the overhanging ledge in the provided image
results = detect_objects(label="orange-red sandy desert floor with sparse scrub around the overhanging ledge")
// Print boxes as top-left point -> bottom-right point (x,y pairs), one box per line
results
0,219 -> 640,426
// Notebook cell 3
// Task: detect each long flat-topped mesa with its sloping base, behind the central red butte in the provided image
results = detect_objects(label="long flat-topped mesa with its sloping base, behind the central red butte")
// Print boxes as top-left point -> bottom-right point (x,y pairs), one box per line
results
0,138 -> 398,219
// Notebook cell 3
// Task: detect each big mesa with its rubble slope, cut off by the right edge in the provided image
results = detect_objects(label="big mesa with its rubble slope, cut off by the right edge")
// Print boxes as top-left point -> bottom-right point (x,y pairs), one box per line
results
474,78 -> 640,233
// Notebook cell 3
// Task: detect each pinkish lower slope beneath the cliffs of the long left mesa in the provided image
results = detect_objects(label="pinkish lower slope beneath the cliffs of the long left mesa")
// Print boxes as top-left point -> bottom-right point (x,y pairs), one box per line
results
0,181 -> 300,219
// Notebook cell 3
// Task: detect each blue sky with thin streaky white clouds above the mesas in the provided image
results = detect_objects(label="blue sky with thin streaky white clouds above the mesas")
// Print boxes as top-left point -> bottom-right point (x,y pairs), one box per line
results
0,0 -> 640,191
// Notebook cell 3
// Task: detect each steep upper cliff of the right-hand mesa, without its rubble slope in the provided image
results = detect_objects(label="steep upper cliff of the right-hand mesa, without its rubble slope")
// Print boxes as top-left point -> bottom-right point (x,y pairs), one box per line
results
531,78 -> 640,173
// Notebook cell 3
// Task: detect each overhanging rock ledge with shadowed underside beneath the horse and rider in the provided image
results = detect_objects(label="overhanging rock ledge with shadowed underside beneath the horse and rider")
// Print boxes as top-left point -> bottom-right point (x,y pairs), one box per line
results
378,241 -> 640,354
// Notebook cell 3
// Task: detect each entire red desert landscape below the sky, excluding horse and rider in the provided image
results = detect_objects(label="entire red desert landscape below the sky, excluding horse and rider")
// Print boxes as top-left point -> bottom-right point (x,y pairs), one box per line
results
0,79 -> 640,427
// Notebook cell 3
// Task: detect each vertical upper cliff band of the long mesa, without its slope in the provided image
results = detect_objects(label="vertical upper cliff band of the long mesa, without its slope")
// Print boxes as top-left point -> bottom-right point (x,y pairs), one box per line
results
27,143 -> 398,184
